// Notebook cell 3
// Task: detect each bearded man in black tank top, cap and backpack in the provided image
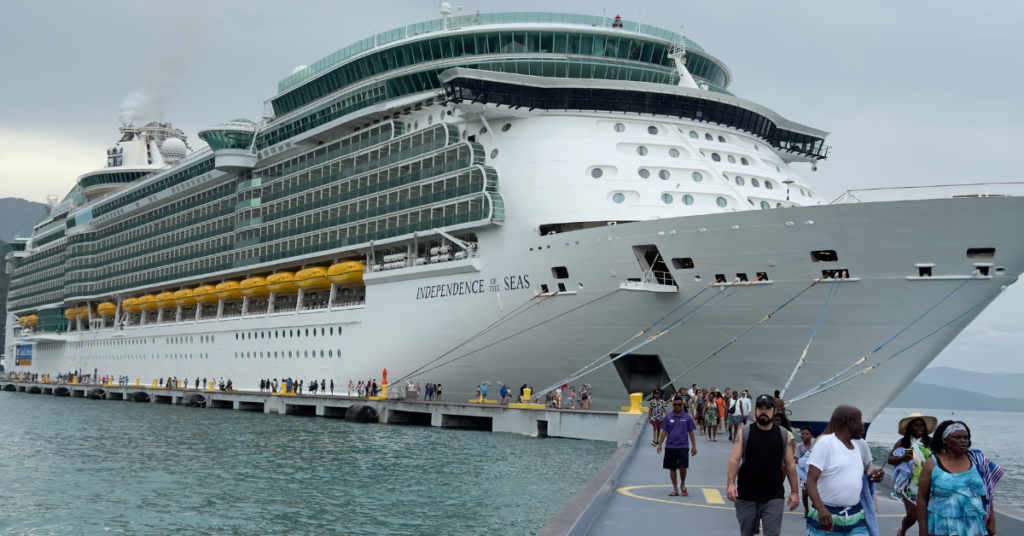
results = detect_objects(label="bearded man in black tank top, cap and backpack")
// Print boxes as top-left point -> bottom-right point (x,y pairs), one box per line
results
726,395 -> 800,536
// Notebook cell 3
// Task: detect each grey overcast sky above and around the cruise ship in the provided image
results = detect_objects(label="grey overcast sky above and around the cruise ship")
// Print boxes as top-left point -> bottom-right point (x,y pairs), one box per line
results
0,0 -> 1024,372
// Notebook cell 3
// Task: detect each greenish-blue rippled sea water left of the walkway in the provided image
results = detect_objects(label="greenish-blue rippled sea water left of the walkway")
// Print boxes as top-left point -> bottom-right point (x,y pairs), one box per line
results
0,393 -> 616,536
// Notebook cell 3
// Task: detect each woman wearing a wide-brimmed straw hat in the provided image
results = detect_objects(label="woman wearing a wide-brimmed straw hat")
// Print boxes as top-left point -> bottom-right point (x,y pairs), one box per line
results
888,413 -> 939,536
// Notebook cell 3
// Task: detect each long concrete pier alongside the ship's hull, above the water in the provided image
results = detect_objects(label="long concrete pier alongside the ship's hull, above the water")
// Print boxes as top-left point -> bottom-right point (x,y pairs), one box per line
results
0,380 -> 641,445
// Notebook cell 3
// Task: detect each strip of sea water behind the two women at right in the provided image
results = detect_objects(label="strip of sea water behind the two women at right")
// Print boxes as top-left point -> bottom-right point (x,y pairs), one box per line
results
867,408 -> 1024,509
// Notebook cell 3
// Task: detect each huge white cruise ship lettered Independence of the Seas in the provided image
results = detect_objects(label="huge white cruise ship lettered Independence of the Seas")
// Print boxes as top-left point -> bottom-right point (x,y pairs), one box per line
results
5,8 -> 1024,427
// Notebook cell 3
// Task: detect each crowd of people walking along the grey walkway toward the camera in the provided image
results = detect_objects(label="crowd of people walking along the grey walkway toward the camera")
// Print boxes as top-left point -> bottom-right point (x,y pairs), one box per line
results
649,385 -> 1002,536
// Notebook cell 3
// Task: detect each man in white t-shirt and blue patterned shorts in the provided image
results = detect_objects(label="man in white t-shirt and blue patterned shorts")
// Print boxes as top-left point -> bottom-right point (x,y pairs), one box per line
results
807,406 -> 883,536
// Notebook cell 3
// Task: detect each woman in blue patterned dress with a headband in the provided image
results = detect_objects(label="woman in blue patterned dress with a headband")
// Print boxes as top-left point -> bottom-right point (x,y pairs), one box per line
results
918,420 -> 1002,536
